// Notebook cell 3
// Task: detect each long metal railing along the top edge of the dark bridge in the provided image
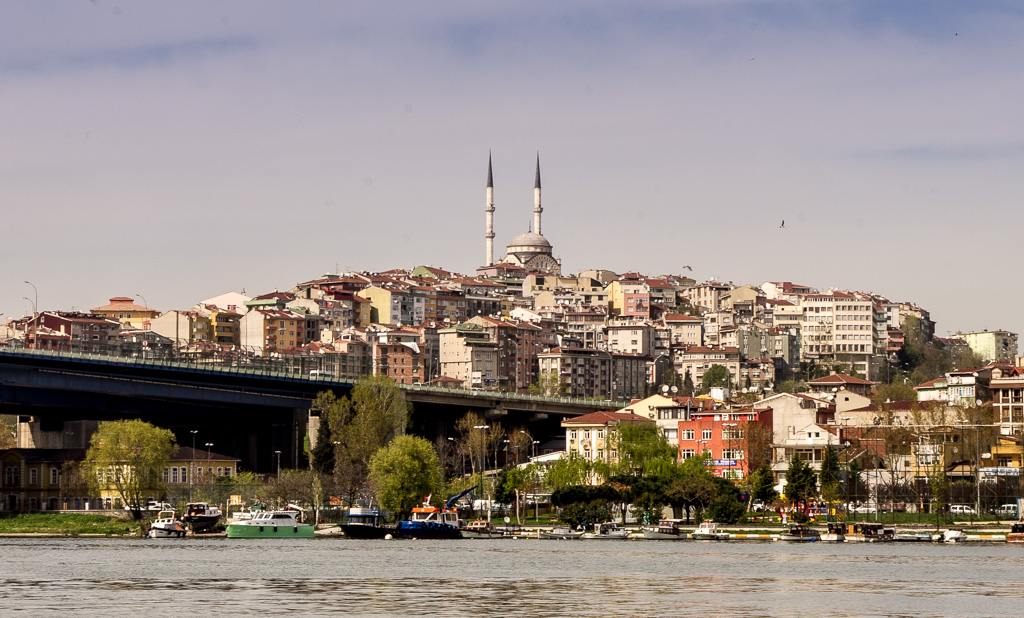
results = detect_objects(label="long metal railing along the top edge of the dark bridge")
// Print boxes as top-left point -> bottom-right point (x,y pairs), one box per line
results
0,348 -> 626,408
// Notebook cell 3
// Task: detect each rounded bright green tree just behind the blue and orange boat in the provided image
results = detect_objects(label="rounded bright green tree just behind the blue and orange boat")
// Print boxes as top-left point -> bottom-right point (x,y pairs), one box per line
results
370,435 -> 443,520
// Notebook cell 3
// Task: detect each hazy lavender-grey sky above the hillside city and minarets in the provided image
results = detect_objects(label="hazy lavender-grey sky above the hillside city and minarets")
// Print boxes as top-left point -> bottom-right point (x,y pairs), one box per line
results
0,0 -> 1024,336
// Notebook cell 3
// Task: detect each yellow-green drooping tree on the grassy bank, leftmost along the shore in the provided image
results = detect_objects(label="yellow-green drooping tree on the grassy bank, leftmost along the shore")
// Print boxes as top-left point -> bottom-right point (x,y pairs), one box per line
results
85,420 -> 177,520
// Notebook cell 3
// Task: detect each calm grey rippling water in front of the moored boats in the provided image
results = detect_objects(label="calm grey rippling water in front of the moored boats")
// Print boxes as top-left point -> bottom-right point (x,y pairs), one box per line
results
0,538 -> 1024,618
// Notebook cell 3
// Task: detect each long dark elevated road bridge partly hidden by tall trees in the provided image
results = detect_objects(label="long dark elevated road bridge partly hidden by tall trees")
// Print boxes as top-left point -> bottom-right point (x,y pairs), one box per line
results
0,350 -> 623,472
